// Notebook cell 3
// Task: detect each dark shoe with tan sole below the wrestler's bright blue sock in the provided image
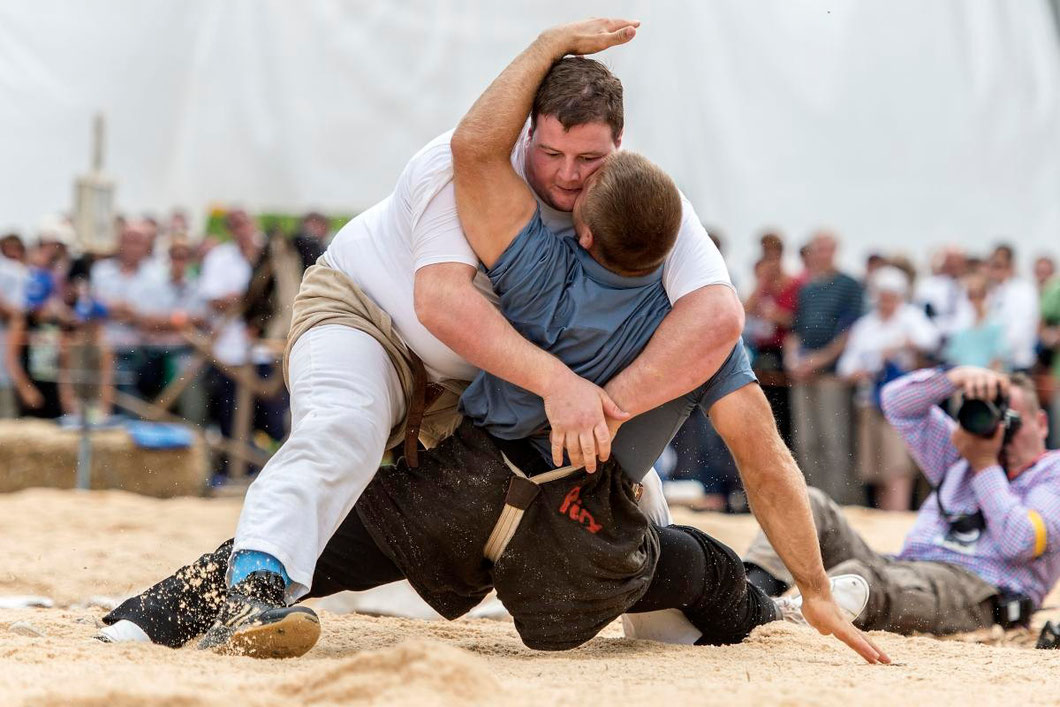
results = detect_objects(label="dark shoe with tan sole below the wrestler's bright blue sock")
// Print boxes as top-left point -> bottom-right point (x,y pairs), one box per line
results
198,571 -> 320,658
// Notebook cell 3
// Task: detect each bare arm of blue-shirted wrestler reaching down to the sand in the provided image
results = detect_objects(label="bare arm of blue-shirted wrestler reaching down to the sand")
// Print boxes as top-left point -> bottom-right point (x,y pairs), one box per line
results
709,385 -> 890,662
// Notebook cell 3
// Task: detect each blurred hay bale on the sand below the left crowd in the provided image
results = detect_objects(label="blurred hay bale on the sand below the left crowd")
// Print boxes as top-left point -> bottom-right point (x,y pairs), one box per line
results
0,420 -> 208,498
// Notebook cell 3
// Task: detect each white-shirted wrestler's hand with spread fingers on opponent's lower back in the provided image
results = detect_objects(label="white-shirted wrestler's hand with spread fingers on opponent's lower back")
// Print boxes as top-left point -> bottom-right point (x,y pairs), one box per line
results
542,373 -> 630,474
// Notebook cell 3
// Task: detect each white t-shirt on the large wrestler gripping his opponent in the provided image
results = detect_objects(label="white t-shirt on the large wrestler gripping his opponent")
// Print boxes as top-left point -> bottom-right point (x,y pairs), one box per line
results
326,130 -> 731,381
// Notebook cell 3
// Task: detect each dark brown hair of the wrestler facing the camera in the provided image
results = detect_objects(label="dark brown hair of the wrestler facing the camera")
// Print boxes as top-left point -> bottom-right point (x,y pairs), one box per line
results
530,56 -> 625,141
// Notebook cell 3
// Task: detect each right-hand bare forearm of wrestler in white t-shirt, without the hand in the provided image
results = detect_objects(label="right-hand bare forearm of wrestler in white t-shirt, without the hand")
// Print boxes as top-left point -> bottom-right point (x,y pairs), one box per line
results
604,285 -> 743,414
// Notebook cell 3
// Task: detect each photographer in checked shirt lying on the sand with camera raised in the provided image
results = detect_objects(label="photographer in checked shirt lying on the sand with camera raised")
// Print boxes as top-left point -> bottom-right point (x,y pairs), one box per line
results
745,367 -> 1060,634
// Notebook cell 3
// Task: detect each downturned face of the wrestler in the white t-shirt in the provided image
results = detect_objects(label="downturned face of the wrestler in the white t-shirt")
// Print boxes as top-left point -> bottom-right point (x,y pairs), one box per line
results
524,116 -> 622,211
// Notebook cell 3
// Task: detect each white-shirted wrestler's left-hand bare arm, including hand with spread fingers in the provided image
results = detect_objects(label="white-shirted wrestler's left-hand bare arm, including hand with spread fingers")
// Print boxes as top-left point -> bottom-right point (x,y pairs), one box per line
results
414,263 -> 629,472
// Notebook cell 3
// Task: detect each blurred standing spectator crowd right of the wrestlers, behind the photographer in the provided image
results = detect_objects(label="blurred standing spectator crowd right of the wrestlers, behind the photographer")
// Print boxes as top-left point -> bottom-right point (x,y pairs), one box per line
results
676,231 -> 1060,510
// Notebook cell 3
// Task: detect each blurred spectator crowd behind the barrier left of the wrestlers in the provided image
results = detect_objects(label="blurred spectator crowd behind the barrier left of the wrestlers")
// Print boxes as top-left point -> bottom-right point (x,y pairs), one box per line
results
0,209 -> 329,482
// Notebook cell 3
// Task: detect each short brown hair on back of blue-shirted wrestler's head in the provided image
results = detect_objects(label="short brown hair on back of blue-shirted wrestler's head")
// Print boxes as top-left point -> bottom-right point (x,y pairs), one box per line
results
581,151 -> 682,275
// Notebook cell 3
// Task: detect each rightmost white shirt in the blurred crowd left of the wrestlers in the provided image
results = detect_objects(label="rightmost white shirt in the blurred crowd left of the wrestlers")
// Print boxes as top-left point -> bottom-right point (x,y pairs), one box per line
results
198,241 -> 252,366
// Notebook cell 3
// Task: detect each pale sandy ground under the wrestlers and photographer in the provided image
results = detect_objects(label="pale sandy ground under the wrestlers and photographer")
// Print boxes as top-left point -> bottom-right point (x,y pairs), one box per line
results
0,490 -> 1060,706
